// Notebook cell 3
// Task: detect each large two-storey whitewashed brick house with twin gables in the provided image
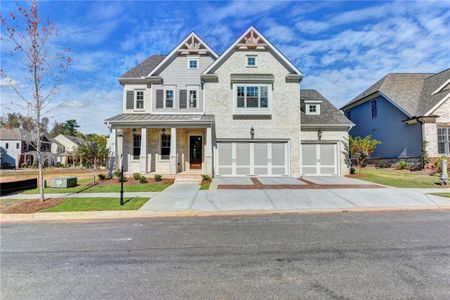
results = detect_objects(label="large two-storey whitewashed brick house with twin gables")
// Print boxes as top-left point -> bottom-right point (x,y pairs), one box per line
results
105,27 -> 350,176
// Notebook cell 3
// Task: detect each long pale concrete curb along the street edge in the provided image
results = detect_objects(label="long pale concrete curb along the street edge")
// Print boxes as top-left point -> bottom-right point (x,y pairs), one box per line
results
0,204 -> 450,224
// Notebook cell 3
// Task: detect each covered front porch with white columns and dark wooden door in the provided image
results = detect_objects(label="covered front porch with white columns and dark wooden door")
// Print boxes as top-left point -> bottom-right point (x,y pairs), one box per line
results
107,114 -> 214,177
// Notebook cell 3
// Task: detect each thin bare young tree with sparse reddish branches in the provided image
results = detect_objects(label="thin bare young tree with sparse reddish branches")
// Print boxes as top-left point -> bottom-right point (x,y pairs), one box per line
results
0,0 -> 72,201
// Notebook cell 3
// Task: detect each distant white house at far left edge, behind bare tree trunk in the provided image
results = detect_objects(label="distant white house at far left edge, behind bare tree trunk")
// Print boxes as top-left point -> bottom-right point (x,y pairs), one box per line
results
0,127 -> 54,168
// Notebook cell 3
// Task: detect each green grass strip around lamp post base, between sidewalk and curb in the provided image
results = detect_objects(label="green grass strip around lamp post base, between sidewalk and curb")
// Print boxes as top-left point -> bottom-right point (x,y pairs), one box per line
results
40,197 -> 148,212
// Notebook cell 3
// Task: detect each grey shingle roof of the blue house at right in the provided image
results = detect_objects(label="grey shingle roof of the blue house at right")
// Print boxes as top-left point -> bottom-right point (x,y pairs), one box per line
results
342,69 -> 450,117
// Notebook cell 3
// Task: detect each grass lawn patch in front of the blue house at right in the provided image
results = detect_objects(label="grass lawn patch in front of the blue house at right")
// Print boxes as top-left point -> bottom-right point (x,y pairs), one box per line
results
357,167 -> 439,188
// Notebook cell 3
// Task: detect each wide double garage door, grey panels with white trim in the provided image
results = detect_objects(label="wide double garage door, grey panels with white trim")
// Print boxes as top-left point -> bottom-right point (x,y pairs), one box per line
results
216,142 -> 289,176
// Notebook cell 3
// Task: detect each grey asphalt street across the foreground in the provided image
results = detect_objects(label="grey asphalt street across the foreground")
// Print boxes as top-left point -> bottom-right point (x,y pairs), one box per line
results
0,211 -> 450,299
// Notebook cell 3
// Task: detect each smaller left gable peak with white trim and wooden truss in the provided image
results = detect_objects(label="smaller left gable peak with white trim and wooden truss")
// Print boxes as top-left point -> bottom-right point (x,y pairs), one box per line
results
146,32 -> 218,77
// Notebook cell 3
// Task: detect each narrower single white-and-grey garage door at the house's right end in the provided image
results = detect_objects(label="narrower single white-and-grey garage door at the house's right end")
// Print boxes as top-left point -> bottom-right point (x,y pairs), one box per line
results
302,144 -> 338,175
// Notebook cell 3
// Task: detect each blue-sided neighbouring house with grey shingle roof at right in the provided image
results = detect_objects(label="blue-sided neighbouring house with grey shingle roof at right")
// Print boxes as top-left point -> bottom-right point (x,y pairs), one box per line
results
342,69 -> 450,164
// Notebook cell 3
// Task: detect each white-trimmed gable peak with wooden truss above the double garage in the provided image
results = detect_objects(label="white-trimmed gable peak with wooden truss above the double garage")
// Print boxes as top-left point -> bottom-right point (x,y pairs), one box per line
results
203,26 -> 303,75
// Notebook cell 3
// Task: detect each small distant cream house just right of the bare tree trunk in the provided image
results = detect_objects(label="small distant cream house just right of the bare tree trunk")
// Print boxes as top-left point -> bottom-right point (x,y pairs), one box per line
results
52,134 -> 83,166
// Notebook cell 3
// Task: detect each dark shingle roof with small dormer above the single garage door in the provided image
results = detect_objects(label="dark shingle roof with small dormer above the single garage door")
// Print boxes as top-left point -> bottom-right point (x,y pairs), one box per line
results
300,89 -> 353,126
